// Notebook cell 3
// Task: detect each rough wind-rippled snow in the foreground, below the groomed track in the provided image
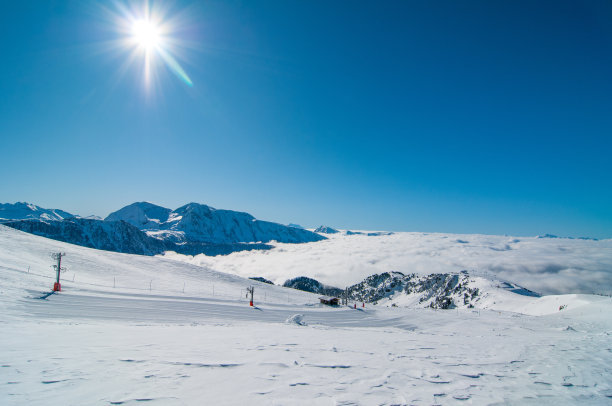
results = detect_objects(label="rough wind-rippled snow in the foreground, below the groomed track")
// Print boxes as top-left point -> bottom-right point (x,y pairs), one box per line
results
0,295 -> 612,405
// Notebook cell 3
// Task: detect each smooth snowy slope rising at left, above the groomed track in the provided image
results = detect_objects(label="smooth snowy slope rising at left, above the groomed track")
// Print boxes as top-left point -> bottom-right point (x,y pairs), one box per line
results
0,223 -> 316,303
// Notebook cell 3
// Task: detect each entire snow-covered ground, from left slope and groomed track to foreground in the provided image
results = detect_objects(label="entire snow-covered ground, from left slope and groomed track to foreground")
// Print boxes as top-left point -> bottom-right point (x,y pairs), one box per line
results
0,226 -> 612,405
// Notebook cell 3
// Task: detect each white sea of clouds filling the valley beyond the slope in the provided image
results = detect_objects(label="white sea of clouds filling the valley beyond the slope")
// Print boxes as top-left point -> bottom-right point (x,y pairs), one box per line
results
166,232 -> 612,294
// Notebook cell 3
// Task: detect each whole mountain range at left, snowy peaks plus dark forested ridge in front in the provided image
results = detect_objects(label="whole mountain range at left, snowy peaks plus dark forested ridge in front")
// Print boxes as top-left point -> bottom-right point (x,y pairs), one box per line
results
0,202 -> 325,255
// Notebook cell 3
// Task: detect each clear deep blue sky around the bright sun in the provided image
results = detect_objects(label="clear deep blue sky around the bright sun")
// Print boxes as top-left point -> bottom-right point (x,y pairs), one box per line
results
0,0 -> 612,238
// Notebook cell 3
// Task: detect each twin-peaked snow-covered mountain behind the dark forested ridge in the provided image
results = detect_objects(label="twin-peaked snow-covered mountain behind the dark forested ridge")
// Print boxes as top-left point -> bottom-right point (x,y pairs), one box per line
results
105,202 -> 325,244
